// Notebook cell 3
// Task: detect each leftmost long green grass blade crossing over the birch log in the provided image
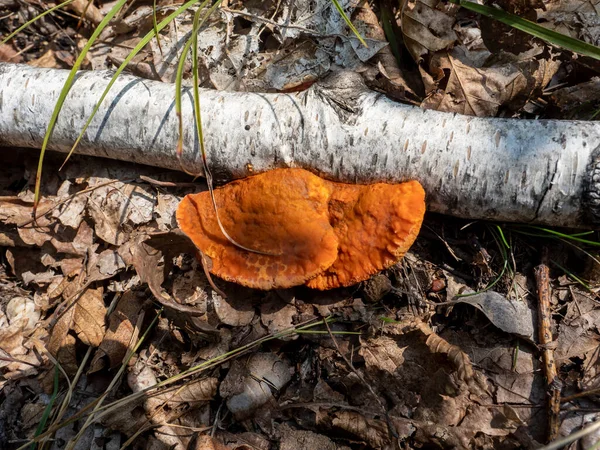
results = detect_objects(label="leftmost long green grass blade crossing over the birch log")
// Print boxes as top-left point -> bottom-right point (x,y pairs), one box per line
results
33,0 -> 127,213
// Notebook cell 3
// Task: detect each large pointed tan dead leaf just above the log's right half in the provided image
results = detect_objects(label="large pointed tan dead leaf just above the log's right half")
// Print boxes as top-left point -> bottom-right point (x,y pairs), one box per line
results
421,48 -> 528,117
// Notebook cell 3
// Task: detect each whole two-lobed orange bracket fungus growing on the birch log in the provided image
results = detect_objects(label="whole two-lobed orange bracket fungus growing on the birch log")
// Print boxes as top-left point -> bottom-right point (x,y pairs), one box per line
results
177,169 -> 425,290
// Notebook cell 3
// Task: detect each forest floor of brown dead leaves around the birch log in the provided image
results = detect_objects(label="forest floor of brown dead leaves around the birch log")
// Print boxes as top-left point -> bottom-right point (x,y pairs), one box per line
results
0,0 -> 600,450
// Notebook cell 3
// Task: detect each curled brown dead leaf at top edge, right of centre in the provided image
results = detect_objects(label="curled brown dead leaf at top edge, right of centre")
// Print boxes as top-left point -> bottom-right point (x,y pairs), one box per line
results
401,0 -> 456,63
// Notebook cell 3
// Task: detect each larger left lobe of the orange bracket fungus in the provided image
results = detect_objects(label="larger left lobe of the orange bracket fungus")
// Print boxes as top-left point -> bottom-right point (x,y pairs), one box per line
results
177,169 -> 338,289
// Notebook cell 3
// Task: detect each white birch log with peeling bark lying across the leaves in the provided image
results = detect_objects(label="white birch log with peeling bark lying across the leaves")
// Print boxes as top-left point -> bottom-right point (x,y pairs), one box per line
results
0,64 -> 600,228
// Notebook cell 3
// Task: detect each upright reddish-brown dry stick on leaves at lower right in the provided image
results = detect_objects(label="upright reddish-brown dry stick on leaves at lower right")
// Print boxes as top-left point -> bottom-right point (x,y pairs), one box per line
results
535,252 -> 561,441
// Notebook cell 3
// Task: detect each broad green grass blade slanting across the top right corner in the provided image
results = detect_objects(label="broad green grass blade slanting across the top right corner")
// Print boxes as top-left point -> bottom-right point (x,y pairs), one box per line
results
452,0 -> 600,59
